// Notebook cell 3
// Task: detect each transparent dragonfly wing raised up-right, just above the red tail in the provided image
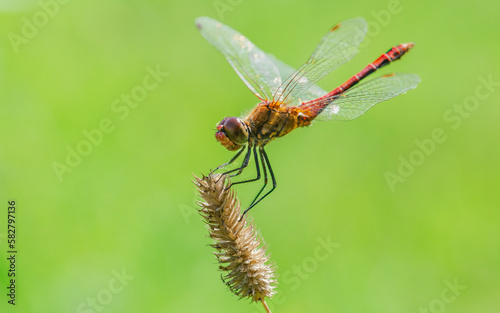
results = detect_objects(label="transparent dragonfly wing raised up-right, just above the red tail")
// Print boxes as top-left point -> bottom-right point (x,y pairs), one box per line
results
273,18 -> 367,105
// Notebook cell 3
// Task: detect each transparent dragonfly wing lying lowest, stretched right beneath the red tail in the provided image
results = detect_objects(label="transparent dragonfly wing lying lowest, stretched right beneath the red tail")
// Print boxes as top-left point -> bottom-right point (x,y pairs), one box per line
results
308,73 -> 420,121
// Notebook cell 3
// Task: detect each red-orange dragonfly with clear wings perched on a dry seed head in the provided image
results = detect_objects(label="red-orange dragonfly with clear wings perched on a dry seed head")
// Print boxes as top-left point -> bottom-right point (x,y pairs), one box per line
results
195,17 -> 420,215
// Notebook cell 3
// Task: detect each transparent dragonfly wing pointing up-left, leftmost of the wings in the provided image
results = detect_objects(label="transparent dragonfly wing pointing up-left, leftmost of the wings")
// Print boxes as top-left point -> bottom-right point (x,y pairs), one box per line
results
195,17 -> 281,100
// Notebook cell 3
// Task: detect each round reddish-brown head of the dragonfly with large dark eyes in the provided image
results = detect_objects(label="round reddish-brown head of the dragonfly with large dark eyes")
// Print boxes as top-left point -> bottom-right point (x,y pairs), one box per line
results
215,117 -> 248,151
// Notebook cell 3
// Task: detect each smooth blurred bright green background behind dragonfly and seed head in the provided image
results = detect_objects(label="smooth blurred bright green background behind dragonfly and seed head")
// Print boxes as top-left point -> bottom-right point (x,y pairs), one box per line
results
0,0 -> 500,313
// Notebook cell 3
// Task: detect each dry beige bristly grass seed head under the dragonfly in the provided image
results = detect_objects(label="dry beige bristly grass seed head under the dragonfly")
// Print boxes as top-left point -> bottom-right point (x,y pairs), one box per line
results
195,174 -> 276,306
